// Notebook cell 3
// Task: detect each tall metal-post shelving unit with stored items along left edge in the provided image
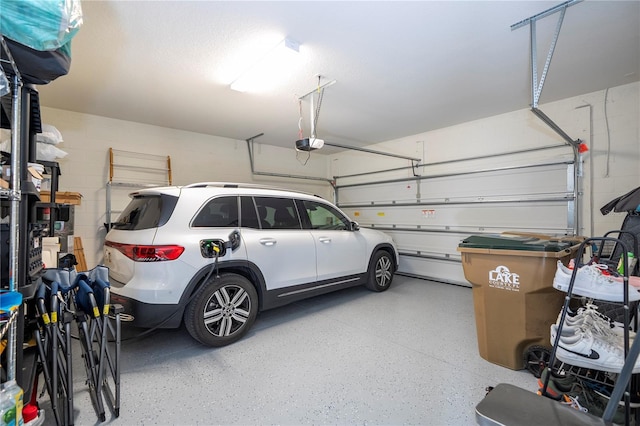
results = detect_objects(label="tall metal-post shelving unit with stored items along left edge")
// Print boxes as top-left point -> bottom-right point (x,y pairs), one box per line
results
0,31 -> 57,422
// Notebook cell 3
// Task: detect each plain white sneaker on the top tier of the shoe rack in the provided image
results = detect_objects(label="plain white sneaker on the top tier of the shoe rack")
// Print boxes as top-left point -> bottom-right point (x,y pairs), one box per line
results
553,261 -> 640,302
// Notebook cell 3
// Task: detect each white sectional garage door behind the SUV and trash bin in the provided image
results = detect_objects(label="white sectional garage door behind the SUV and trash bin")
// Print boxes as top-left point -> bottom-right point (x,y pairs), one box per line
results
336,148 -> 577,284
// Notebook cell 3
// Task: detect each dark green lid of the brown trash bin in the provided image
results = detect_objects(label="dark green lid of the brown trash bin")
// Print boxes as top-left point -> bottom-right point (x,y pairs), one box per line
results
458,234 -> 572,252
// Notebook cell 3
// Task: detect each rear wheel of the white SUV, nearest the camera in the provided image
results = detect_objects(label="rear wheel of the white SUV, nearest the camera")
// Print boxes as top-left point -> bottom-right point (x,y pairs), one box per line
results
184,274 -> 258,347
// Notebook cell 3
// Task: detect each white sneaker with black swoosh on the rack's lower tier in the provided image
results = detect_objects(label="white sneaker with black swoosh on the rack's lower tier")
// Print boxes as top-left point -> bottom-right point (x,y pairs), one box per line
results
551,324 -> 640,374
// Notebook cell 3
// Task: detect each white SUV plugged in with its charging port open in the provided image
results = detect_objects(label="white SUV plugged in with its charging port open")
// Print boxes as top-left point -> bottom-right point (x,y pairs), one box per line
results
104,182 -> 398,346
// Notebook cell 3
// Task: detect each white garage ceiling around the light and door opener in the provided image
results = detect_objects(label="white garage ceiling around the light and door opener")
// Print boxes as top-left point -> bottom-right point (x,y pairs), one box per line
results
40,0 -> 640,153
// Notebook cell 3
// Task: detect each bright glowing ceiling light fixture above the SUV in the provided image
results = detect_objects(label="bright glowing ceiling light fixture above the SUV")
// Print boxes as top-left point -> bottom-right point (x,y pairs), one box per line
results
229,37 -> 300,92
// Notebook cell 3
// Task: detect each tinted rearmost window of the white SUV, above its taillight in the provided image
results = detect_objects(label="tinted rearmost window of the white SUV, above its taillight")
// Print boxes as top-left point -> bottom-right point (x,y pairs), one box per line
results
111,194 -> 178,231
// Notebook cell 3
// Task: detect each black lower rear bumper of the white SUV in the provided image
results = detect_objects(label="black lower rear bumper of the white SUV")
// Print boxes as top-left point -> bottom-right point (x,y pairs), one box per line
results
111,292 -> 184,328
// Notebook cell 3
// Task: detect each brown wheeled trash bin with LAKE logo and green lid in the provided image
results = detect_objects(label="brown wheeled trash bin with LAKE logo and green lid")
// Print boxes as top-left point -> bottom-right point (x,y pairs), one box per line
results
458,234 -> 579,370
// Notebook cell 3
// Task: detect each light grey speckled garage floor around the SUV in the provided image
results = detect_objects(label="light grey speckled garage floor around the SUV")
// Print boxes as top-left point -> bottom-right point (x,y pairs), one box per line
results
41,276 -> 537,425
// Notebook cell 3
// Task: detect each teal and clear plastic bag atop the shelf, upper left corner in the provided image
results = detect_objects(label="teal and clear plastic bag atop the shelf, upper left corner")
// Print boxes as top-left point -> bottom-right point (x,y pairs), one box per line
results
0,0 -> 82,51
